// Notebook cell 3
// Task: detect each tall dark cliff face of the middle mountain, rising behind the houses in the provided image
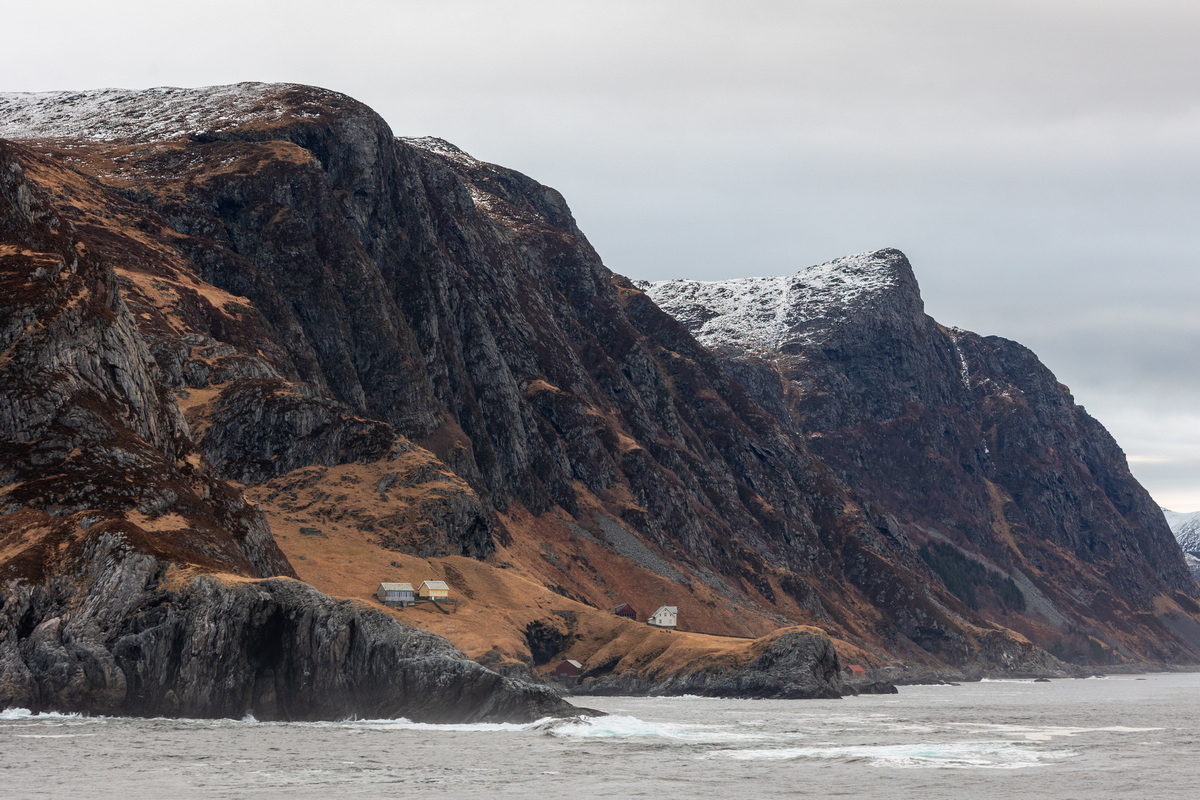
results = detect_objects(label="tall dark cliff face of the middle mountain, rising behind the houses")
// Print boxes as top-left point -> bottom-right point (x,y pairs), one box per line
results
2,86 -> 892,632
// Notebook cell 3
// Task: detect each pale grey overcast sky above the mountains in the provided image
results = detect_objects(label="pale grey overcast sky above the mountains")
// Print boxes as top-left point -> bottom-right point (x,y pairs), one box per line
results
0,0 -> 1200,511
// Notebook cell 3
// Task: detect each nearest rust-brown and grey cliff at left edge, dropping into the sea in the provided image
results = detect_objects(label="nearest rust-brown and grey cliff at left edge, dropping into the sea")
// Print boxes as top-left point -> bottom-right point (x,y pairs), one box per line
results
0,128 -> 569,721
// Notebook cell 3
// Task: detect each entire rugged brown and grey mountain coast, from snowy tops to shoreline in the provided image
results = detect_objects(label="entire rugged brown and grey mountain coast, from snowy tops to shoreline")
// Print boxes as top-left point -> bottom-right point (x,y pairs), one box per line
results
0,84 -> 1200,716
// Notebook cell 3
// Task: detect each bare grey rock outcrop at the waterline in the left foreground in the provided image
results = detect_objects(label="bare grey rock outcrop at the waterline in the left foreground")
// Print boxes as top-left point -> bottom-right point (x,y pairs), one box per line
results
0,534 -> 575,722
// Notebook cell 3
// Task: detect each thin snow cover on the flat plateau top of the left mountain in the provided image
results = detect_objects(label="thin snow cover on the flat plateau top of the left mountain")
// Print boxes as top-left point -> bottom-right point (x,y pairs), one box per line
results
0,83 -> 338,142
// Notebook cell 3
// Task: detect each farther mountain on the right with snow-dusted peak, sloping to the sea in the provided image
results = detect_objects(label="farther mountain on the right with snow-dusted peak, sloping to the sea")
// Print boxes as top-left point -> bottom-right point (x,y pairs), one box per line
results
644,251 -> 1196,658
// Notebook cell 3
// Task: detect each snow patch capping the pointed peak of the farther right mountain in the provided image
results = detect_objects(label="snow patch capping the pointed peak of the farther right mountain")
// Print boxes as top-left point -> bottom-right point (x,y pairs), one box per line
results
637,249 -> 919,351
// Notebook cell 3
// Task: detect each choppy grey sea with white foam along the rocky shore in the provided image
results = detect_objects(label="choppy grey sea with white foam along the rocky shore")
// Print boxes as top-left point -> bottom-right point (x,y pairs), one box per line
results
0,673 -> 1200,800
